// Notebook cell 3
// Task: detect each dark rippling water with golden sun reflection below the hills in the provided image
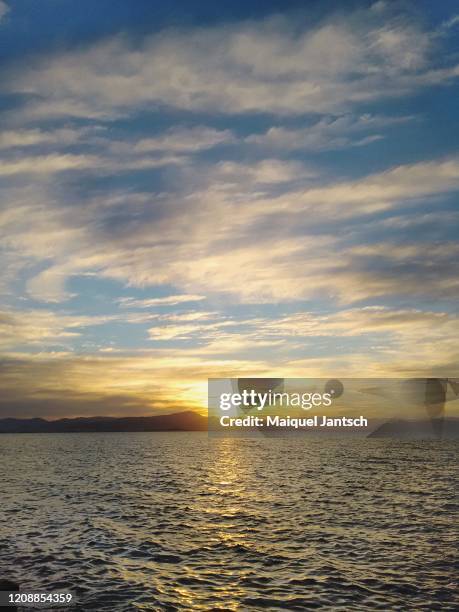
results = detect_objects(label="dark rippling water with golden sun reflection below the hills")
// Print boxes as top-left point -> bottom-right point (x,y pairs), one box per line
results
0,433 -> 458,610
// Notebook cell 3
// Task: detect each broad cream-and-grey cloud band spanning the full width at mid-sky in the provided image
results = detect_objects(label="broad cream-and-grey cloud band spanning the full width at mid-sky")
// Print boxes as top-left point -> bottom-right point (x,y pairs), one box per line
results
0,158 -> 459,306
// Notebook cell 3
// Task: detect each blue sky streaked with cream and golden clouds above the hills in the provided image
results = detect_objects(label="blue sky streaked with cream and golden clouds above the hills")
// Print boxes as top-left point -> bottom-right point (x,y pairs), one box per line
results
0,0 -> 459,418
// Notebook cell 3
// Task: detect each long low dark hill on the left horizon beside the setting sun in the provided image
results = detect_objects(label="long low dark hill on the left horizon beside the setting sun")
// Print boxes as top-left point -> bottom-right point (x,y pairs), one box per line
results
0,411 -> 207,433
